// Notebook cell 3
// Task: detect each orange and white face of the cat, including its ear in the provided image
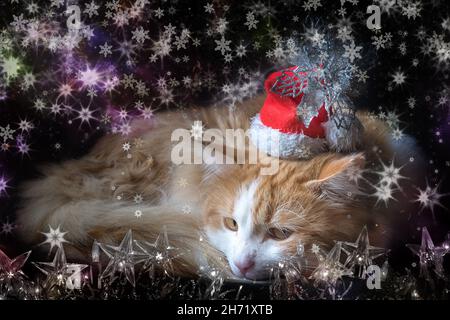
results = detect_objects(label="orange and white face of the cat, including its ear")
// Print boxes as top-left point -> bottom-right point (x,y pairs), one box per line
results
205,155 -> 366,280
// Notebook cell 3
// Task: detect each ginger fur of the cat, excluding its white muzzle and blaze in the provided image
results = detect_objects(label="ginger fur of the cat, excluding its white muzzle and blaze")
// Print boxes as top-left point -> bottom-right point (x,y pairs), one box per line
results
18,96 -> 416,274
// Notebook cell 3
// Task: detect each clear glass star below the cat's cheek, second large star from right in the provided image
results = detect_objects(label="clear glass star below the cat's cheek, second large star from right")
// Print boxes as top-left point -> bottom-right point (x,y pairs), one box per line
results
342,226 -> 386,279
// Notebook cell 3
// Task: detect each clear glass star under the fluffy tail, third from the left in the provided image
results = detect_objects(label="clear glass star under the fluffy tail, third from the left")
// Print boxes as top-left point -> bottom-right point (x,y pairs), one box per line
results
93,230 -> 147,287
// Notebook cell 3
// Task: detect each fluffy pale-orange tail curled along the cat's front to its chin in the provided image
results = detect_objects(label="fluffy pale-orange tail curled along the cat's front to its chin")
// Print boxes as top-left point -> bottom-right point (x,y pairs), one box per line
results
18,188 -> 227,276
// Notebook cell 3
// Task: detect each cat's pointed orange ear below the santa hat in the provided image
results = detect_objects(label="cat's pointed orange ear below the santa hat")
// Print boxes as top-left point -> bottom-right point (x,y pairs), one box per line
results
305,153 -> 366,197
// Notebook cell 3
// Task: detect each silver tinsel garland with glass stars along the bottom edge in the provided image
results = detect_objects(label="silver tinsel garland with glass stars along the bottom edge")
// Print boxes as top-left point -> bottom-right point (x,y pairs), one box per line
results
0,227 -> 450,300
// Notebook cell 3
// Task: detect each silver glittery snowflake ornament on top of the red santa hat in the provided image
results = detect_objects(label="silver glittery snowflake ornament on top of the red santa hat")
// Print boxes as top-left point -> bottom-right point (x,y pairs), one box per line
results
271,40 -> 356,130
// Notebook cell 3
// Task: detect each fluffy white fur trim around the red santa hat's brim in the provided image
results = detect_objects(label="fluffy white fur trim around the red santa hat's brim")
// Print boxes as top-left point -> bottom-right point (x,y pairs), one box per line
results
249,114 -> 327,159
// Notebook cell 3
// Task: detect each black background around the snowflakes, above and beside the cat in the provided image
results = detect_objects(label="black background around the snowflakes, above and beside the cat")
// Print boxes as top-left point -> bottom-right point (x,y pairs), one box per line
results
0,0 -> 450,282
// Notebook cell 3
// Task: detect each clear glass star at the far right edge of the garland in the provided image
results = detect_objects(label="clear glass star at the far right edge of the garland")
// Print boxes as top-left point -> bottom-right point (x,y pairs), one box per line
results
406,227 -> 449,279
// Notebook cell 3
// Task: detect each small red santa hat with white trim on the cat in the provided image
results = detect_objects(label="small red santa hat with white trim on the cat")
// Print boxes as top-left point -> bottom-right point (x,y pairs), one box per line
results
250,66 -> 359,159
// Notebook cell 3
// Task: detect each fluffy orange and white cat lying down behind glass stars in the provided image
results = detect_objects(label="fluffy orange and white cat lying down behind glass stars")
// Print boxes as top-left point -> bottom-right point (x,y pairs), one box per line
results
17,96 -> 422,280
